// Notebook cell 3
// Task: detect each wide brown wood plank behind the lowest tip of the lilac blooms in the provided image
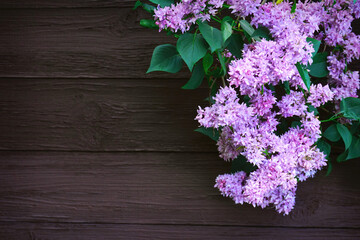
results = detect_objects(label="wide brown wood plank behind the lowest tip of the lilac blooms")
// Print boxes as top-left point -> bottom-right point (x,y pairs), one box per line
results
0,152 -> 360,228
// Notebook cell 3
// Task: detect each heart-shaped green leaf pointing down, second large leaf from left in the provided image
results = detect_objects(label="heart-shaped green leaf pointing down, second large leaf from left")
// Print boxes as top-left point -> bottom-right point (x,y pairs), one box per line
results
176,33 -> 207,71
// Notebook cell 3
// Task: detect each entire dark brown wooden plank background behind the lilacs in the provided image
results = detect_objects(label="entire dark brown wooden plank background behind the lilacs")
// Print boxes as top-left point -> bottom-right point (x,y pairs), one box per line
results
0,0 -> 360,240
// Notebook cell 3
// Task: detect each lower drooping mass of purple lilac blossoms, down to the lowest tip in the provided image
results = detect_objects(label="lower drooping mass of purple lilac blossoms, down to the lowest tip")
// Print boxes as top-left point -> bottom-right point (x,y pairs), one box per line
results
196,87 -> 326,214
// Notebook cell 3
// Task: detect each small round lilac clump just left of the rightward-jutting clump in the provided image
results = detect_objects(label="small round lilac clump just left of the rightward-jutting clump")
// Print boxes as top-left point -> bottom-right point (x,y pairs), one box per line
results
277,90 -> 307,117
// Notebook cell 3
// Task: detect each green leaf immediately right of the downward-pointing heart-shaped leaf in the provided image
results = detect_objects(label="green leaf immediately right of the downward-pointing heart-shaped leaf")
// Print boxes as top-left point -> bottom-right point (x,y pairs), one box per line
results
198,21 -> 223,52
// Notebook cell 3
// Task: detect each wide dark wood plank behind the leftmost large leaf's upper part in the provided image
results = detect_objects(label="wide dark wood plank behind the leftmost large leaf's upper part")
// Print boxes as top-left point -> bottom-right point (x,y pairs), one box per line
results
0,8 -> 190,78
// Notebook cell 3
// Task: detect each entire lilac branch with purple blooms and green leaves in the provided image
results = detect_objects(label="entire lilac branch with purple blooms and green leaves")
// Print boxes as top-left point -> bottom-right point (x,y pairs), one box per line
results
135,0 -> 360,214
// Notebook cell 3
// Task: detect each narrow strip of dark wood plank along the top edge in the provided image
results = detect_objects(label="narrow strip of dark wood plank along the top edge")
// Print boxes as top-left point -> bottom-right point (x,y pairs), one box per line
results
0,0 -> 134,8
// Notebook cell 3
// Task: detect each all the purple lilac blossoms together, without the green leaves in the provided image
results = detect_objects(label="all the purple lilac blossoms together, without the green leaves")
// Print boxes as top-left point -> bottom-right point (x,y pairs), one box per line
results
151,0 -> 360,214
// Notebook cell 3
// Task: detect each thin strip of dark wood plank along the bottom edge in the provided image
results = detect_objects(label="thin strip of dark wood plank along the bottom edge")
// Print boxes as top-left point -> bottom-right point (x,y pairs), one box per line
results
0,223 -> 360,240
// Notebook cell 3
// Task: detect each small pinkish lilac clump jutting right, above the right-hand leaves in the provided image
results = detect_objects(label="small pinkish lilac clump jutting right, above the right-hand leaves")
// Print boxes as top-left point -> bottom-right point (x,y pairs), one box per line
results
307,84 -> 334,107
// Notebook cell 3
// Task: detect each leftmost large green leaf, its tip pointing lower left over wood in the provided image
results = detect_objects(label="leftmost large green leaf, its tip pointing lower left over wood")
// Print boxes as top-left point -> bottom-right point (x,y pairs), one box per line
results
146,44 -> 183,73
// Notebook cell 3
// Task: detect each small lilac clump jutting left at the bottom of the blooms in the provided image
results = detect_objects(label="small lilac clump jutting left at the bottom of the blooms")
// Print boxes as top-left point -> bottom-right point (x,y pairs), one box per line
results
215,172 -> 246,204
